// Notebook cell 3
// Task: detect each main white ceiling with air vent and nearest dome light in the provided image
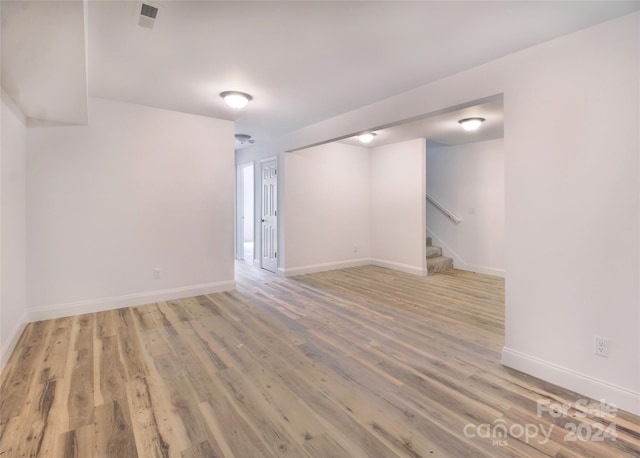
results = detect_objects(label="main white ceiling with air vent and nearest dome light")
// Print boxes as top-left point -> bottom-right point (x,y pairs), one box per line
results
2,0 -> 640,142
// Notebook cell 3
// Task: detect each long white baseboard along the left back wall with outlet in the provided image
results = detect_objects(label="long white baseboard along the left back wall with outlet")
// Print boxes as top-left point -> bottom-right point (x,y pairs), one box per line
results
29,280 -> 236,321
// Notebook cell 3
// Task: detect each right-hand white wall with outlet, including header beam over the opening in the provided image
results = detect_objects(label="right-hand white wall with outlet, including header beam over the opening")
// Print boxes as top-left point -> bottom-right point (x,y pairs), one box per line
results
279,13 -> 640,414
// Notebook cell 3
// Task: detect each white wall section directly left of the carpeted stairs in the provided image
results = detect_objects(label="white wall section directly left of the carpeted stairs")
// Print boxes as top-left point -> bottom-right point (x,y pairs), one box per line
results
371,139 -> 427,275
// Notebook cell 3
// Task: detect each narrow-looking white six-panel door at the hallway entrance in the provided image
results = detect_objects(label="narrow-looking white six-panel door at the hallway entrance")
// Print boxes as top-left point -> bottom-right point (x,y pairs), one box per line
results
260,159 -> 278,273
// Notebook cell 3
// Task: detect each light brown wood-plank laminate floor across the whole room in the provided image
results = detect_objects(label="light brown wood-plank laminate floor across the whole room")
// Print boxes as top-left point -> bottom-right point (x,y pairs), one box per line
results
0,264 -> 640,458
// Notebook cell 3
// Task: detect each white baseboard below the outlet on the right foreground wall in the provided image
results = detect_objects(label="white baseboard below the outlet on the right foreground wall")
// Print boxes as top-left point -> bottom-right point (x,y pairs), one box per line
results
502,347 -> 640,415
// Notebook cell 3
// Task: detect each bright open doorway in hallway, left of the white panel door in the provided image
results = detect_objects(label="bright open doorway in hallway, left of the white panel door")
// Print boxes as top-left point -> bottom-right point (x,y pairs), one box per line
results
236,162 -> 255,264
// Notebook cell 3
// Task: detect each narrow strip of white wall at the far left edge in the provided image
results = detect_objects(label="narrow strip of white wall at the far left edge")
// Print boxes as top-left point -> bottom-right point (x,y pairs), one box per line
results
0,90 -> 27,370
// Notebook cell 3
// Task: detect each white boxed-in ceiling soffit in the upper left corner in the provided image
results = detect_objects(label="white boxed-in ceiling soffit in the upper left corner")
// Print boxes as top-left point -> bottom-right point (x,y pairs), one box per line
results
0,1 -> 87,124
